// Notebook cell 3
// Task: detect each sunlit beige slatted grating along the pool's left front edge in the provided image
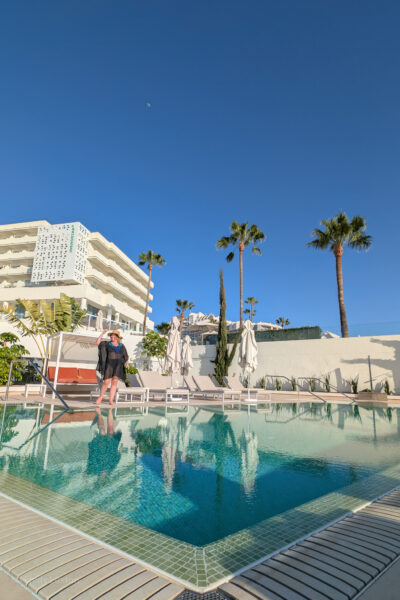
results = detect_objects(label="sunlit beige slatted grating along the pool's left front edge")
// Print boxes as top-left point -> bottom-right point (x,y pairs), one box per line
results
0,496 -> 184,600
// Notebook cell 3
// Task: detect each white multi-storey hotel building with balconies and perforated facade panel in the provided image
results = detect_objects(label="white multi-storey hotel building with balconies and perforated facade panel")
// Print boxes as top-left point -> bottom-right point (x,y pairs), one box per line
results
0,221 -> 154,352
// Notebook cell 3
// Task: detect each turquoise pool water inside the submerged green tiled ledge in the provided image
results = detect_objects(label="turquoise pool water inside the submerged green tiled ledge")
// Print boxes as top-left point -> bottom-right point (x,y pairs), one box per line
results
0,404 -> 400,546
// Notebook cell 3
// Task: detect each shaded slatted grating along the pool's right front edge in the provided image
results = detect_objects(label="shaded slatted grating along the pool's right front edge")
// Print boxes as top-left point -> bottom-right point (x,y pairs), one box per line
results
219,490 -> 400,600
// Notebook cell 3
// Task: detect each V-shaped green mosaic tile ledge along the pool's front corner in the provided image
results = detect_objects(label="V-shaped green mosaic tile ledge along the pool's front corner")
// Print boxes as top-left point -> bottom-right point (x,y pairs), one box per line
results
0,446 -> 400,592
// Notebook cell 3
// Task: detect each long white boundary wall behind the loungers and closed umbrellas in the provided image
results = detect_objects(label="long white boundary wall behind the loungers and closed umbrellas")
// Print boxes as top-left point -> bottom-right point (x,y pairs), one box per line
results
193,335 -> 400,393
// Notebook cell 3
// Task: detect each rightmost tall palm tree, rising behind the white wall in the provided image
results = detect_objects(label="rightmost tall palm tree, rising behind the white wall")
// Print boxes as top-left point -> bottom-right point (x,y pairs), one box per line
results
307,212 -> 372,337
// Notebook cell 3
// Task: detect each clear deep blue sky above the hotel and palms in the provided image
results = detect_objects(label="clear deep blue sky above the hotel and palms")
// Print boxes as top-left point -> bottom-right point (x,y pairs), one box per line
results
0,0 -> 400,331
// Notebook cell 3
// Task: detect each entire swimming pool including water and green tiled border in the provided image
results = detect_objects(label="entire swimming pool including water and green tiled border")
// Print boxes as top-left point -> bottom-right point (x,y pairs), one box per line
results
0,404 -> 400,587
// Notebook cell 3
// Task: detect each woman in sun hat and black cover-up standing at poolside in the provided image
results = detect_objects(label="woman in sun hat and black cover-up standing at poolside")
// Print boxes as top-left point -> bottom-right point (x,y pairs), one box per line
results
96,329 -> 128,405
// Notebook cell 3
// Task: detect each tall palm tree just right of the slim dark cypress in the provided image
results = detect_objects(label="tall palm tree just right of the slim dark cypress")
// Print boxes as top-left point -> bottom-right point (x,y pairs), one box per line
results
217,221 -> 266,329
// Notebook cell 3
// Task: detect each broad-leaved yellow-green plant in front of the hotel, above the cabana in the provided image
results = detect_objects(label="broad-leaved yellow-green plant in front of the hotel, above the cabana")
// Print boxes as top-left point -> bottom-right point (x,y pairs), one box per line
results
0,293 -> 86,360
